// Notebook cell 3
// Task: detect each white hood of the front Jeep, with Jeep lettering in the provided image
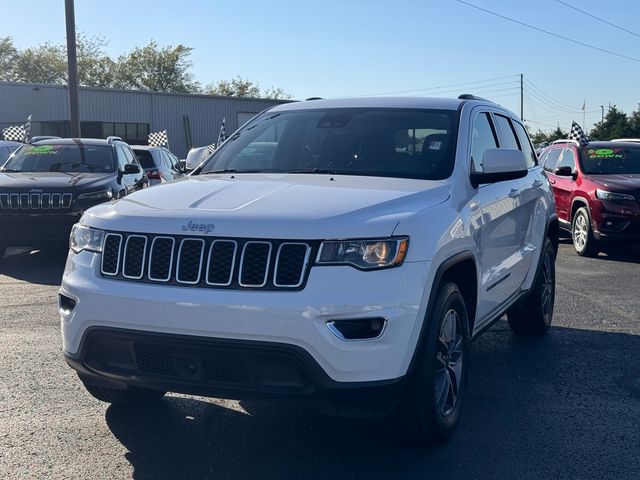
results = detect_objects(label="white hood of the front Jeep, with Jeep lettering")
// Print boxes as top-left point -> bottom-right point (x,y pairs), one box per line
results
82,174 -> 449,239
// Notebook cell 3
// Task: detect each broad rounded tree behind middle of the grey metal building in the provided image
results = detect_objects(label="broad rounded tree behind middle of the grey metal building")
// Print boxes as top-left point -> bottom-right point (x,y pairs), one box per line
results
114,40 -> 200,93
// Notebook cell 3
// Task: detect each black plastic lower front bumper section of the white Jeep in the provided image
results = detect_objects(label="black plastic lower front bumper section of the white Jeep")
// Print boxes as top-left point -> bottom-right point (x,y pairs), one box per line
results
66,328 -> 404,417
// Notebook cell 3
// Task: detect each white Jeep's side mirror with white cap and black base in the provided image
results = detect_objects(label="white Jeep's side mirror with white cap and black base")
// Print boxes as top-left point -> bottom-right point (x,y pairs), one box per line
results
470,148 -> 528,188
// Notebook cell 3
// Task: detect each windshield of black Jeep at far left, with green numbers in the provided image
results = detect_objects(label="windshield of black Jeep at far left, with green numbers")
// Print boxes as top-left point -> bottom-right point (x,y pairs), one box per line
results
3,145 -> 115,173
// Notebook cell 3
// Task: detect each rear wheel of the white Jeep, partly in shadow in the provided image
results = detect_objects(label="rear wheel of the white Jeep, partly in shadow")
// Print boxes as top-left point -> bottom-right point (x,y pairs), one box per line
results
507,238 -> 556,335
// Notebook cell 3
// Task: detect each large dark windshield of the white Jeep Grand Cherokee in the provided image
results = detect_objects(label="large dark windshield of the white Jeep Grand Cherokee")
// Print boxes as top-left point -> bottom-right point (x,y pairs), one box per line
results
200,109 -> 457,180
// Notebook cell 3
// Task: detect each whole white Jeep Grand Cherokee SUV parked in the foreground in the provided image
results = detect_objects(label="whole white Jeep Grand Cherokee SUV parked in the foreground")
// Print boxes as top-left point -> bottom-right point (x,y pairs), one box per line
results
59,95 -> 558,443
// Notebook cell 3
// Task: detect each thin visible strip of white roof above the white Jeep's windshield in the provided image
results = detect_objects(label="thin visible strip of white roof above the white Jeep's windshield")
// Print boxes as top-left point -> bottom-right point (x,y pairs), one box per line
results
269,97 -> 468,112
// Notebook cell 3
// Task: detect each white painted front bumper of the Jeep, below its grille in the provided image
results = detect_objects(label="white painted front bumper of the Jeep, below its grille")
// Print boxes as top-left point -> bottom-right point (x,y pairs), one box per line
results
60,252 -> 433,382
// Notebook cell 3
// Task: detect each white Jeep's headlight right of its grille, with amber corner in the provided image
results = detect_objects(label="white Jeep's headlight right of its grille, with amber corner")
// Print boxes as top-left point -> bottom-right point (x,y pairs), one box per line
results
316,237 -> 409,270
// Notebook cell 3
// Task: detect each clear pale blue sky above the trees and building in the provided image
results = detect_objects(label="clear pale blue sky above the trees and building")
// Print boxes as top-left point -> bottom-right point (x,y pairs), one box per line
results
0,0 -> 640,130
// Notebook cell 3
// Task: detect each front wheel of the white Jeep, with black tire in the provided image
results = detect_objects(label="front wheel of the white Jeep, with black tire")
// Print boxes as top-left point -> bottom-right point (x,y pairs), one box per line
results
391,283 -> 469,445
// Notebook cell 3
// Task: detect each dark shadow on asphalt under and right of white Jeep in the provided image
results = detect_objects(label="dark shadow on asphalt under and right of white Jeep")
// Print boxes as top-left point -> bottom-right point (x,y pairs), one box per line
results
106,321 -> 640,480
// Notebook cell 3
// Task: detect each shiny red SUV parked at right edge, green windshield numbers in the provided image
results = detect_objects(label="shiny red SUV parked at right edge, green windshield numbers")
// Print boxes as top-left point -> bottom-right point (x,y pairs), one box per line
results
540,140 -> 640,256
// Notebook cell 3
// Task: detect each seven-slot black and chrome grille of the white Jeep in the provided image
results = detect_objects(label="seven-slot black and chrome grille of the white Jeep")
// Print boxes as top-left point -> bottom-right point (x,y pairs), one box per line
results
101,233 -> 317,290
